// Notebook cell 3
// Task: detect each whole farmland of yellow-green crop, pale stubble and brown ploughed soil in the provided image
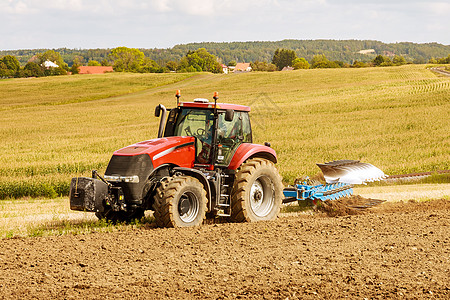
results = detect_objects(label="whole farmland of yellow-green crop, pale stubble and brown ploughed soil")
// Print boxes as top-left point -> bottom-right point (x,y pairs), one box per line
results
0,66 -> 450,299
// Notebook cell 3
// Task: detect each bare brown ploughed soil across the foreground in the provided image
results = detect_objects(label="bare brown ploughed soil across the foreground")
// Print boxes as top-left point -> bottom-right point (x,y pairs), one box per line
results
0,199 -> 450,299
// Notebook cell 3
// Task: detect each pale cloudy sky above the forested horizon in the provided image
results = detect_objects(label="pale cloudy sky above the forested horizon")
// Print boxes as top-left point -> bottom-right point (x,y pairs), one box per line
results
0,0 -> 450,50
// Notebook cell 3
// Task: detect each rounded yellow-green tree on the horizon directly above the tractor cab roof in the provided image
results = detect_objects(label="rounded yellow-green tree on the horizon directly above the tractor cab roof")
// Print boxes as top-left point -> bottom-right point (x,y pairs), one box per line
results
179,48 -> 223,73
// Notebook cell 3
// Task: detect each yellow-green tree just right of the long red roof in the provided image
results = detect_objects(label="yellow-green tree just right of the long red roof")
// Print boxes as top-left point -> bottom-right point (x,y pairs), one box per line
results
109,47 -> 145,72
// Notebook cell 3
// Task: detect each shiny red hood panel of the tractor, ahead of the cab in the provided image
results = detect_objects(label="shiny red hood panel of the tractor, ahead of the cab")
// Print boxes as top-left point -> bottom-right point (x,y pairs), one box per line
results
114,136 -> 195,168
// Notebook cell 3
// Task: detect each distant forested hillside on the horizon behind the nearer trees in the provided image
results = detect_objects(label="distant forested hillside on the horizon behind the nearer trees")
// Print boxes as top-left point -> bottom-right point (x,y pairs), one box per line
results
0,40 -> 450,66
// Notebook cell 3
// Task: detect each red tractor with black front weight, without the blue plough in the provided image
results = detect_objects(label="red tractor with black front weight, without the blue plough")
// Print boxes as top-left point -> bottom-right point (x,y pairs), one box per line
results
70,91 -> 283,227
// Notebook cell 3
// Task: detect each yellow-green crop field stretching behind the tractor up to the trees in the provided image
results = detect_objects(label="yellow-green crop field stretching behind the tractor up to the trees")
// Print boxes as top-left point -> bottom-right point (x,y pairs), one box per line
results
0,65 -> 450,198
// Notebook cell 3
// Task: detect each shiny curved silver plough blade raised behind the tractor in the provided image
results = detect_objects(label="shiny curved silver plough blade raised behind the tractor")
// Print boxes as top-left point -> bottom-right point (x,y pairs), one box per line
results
317,160 -> 388,184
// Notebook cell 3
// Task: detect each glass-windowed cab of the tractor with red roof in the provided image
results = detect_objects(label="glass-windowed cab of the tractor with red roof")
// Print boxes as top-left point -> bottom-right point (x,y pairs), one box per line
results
157,95 -> 252,167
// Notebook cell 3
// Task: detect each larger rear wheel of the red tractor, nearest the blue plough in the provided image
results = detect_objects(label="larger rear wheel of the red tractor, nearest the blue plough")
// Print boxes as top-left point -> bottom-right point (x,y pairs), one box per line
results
231,158 -> 283,222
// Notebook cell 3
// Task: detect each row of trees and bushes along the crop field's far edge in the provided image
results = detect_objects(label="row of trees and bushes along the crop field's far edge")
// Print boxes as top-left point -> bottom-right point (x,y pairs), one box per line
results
0,47 -> 450,78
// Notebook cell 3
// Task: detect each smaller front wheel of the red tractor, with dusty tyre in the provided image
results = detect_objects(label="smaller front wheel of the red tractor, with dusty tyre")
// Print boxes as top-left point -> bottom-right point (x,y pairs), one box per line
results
153,175 -> 207,227
